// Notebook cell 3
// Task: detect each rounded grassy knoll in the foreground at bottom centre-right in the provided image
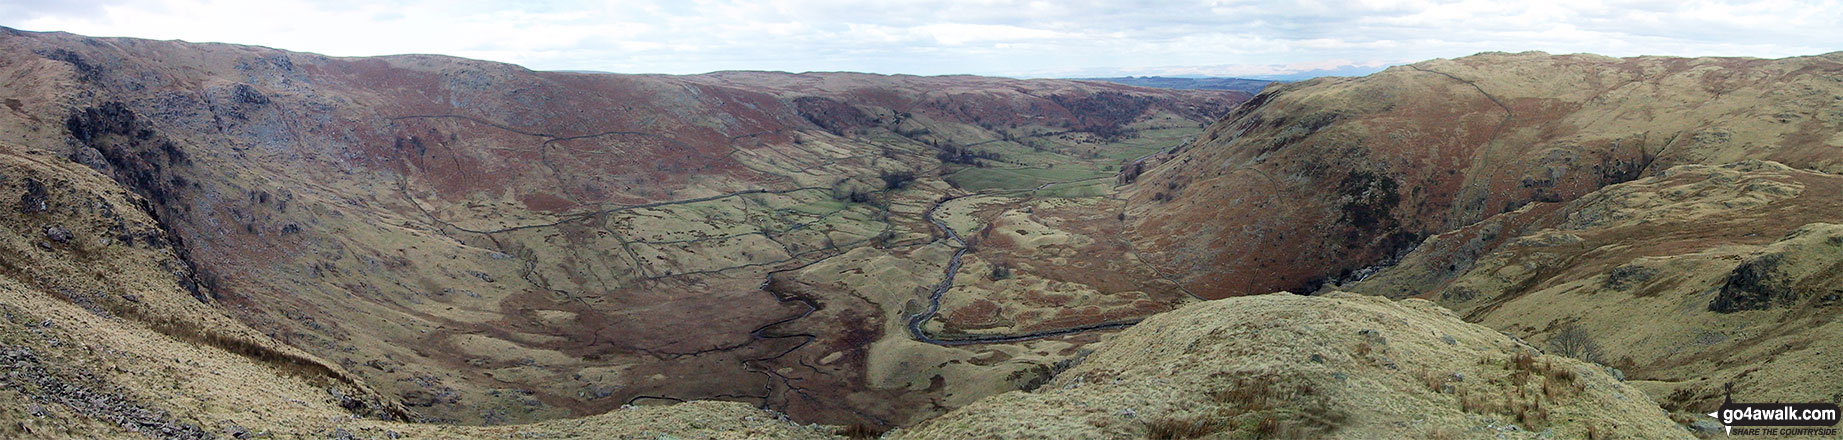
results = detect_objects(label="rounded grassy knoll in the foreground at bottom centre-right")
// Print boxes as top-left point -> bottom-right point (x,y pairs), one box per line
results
896,293 -> 1690,438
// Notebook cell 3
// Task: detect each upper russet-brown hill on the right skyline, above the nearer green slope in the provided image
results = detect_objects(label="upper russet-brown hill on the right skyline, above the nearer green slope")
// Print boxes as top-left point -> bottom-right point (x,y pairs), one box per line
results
1128,53 -> 1843,298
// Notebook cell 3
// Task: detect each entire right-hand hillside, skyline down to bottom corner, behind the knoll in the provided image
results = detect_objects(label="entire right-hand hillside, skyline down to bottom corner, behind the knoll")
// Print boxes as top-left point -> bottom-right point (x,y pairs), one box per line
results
1128,53 -> 1843,423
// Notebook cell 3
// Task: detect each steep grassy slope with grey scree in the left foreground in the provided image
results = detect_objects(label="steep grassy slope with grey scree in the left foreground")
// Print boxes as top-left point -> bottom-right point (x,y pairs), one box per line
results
0,142 -> 407,438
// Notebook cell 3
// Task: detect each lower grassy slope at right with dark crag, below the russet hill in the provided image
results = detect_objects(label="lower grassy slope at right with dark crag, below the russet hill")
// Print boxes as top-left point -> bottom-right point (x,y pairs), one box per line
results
1338,160 -> 1843,423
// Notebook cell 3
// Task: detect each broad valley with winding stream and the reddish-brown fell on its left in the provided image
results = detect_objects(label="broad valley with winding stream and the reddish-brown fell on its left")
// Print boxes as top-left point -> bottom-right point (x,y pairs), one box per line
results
7,33 -> 1248,427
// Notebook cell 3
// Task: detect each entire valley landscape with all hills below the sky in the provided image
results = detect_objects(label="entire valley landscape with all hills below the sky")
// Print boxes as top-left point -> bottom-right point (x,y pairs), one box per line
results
0,28 -> 1843,438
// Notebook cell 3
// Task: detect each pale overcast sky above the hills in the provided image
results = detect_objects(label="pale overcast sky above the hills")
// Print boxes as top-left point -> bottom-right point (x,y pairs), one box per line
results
0,0 -> 1843,77
